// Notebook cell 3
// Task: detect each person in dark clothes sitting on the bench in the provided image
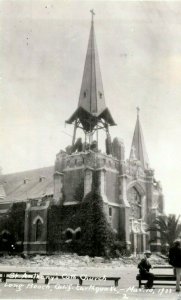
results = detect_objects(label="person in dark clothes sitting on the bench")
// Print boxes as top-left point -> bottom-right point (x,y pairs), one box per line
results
138,250 -> 154,289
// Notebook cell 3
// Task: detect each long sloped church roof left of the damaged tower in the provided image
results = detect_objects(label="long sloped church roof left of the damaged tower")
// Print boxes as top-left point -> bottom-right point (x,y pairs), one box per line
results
0,166 -> 54,202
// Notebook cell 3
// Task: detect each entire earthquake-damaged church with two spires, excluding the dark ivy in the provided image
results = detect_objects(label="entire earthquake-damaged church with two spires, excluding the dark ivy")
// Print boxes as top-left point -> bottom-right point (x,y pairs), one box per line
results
0,11 -> 164,254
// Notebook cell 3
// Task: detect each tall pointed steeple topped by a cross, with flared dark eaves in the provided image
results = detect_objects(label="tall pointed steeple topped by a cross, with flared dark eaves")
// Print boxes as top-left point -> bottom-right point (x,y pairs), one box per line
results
66,10 -> 116,143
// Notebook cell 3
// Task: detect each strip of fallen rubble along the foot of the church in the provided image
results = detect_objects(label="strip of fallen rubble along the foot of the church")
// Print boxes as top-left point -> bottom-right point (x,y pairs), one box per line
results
0,253 -> 168,268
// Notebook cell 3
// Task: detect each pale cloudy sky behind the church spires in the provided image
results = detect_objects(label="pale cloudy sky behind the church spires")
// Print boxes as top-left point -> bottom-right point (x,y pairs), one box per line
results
0,0 -> 181,214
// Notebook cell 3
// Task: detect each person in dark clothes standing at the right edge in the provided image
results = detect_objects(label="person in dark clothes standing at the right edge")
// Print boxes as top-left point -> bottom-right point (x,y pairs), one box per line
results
168,240 -> 181,292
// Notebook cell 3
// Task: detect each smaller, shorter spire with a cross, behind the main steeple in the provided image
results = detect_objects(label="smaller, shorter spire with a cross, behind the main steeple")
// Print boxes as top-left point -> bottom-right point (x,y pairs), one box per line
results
130,107 -> 149,169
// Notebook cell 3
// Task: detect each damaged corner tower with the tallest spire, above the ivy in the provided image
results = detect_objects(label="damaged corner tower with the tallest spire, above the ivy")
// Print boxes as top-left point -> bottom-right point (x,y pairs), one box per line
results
54,10 -> 123,239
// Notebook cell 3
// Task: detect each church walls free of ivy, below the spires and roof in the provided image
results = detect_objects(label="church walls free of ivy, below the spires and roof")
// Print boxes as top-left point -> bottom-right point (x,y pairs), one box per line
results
0,140 -> 164,253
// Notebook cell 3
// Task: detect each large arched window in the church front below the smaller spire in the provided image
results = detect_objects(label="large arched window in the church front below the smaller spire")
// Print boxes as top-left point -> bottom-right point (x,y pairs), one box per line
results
128,187 -> 141,219
